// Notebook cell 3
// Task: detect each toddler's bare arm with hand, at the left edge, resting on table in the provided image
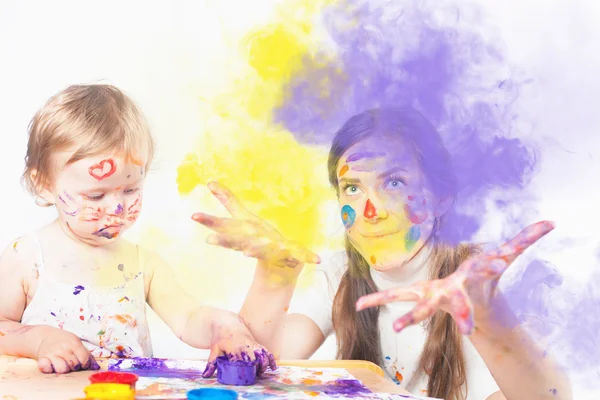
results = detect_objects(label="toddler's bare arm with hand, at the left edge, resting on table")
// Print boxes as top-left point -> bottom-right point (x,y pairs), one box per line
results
0,236 -> 98,373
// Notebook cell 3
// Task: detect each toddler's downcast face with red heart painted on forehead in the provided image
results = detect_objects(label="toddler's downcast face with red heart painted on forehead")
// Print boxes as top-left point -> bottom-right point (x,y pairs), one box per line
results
47,155 -> 146,246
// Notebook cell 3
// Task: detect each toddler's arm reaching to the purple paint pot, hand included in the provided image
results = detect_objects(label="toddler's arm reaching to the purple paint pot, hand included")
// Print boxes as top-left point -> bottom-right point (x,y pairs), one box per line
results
146,253 -> 275,376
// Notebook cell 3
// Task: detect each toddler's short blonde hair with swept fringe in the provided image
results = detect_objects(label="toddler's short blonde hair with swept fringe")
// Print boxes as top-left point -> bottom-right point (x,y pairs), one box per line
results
22,84 -> 154,205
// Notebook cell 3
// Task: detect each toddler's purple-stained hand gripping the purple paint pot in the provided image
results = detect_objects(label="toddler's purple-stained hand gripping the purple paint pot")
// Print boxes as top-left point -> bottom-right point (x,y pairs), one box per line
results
202,311 -> 277,378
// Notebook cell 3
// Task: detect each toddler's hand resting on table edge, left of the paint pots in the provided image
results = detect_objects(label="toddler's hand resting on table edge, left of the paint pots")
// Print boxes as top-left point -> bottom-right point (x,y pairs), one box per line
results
37,327 -> 100,374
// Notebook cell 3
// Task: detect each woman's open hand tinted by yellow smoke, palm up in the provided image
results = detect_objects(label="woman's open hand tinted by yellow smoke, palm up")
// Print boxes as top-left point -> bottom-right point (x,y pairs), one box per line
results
192,182 -> 320,281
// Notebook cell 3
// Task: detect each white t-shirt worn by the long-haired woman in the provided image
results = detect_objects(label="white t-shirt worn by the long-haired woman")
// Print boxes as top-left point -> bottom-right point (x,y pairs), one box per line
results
289,248 -> 499,400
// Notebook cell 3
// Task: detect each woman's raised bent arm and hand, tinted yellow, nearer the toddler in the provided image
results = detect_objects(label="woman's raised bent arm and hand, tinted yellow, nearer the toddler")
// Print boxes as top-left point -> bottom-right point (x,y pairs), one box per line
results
192,182 -> 325,357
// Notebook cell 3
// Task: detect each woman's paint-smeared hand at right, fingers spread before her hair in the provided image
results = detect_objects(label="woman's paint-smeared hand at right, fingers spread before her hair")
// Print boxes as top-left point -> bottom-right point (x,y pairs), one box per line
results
356,221 -> 554,335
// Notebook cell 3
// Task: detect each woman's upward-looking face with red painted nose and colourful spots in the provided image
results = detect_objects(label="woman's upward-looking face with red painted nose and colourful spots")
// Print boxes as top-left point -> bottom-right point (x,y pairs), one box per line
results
337,137 -> 436,271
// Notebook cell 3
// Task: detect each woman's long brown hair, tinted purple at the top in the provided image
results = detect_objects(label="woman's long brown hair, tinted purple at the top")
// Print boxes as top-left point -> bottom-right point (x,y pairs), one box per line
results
328,107 -> 475,400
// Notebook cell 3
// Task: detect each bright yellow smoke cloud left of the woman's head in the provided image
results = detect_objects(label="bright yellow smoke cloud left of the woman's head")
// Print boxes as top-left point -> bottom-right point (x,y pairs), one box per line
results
177,0 -> 342,256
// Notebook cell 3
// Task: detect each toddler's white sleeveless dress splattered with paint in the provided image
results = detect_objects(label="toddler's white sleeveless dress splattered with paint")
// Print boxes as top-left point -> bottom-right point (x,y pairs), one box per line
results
21,234 -> 152,357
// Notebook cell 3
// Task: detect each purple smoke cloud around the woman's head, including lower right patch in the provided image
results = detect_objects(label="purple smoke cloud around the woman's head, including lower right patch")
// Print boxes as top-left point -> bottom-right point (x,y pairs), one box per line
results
275,0 -> 600,388
